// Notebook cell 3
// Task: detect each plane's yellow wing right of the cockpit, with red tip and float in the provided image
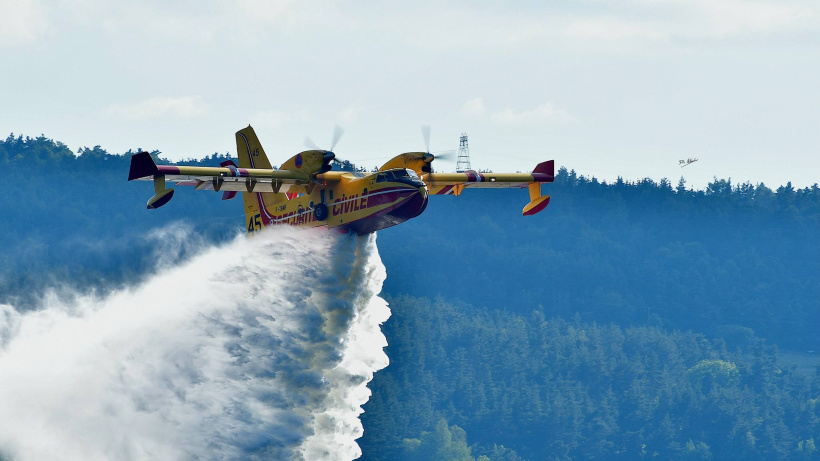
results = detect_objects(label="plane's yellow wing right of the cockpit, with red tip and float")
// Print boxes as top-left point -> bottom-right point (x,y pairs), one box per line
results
421,160 -> 555,216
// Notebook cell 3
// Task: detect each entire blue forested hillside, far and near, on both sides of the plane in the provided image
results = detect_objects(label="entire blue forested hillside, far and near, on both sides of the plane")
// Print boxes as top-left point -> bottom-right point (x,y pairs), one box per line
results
0,135 -> 820,460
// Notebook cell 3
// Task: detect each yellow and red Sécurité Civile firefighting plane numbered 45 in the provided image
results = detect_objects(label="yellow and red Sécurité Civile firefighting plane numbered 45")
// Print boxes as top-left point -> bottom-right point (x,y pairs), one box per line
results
128,125 -> 555,235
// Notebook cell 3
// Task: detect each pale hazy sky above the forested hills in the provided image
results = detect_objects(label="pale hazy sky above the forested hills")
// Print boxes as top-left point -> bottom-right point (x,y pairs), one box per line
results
0,0 -> 820,188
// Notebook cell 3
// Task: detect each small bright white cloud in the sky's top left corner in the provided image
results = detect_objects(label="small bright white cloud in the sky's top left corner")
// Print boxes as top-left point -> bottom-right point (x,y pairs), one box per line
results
0,0 -> 48,46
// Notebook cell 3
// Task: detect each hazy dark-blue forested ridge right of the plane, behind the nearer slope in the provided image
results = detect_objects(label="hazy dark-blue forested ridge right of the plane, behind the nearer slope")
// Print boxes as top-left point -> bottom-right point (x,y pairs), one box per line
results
379,164 -> 820,351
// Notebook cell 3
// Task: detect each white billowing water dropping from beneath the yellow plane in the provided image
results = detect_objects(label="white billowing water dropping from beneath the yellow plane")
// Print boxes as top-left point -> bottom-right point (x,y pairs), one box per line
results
0,228 -> 390,460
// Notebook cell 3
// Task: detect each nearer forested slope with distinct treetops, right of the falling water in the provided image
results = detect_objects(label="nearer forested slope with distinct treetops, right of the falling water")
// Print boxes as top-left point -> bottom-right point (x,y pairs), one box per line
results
360,296 -> 820,461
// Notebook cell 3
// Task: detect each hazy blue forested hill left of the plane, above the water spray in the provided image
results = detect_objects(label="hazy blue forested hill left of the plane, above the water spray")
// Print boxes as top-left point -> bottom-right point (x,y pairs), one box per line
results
0,136 -> 244,307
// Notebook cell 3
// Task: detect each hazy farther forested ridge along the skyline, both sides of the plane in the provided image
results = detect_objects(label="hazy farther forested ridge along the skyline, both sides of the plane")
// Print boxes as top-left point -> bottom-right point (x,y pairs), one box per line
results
0,135 -> 820,351
